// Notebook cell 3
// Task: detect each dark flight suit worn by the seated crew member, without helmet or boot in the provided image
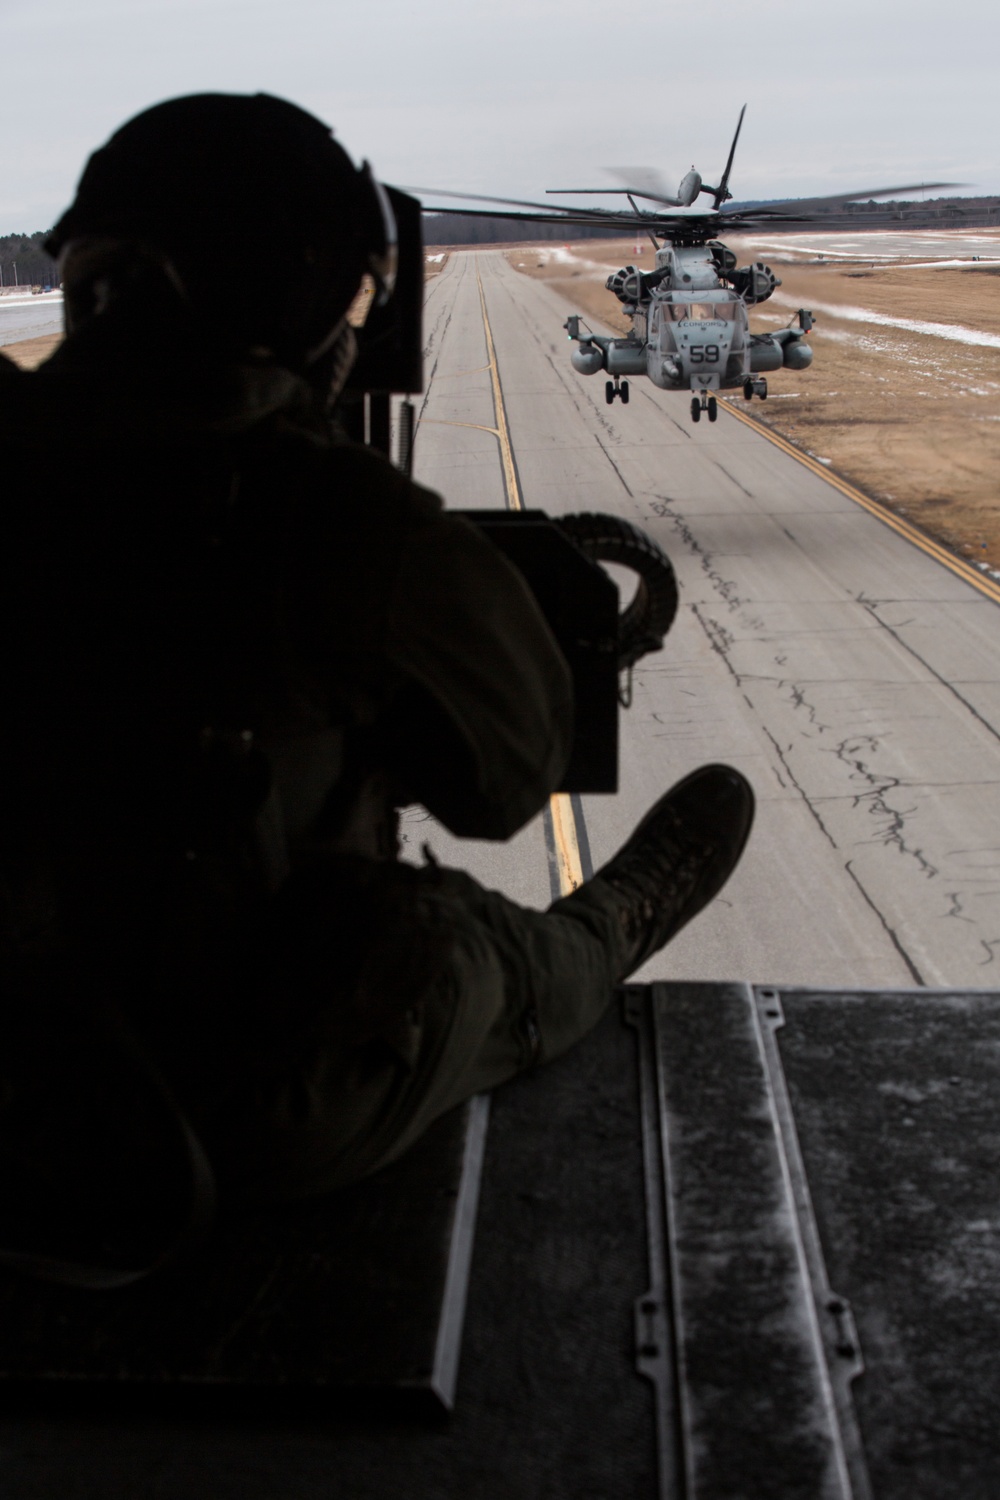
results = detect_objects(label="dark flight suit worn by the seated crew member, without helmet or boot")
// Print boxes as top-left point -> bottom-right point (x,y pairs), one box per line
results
0,315 -> 624,1200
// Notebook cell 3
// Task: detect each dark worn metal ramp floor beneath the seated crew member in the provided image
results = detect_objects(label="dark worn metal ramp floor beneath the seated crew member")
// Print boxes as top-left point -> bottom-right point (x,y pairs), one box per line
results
0,984 -> 1000,1500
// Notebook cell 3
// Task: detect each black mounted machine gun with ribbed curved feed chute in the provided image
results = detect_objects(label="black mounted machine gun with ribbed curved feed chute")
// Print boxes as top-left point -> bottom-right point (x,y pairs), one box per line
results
337,188 -> 678,792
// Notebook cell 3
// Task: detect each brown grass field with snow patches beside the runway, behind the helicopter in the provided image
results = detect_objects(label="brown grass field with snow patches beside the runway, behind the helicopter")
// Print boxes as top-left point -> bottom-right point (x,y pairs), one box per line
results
507,234 -> 1000,569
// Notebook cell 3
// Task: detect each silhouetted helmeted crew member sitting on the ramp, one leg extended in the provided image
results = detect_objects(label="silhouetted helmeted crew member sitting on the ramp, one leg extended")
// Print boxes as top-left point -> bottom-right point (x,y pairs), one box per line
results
0,95 -> 753,1199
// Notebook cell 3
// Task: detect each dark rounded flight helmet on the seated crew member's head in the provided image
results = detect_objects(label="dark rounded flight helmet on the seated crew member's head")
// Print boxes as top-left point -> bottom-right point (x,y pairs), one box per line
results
46,95 -> 396,371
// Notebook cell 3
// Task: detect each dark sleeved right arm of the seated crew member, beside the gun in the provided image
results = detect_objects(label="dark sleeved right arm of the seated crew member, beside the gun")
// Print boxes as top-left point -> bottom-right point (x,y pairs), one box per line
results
284,447 -> 573,839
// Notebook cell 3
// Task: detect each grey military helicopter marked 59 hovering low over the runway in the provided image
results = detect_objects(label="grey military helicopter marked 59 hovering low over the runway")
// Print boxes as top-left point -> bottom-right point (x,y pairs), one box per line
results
414,105 -> 955,422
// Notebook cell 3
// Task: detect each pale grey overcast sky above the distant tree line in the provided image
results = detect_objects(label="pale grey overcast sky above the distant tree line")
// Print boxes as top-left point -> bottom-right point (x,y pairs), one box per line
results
0,0 -> 1000,234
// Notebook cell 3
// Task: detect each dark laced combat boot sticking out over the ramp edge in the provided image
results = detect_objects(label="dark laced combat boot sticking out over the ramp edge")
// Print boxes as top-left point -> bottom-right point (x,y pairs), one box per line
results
553,765 -> 754,980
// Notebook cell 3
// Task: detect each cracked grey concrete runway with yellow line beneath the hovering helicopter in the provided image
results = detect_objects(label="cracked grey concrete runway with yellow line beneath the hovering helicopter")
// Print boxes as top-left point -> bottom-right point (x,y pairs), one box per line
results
405,252 -> 1000,989
